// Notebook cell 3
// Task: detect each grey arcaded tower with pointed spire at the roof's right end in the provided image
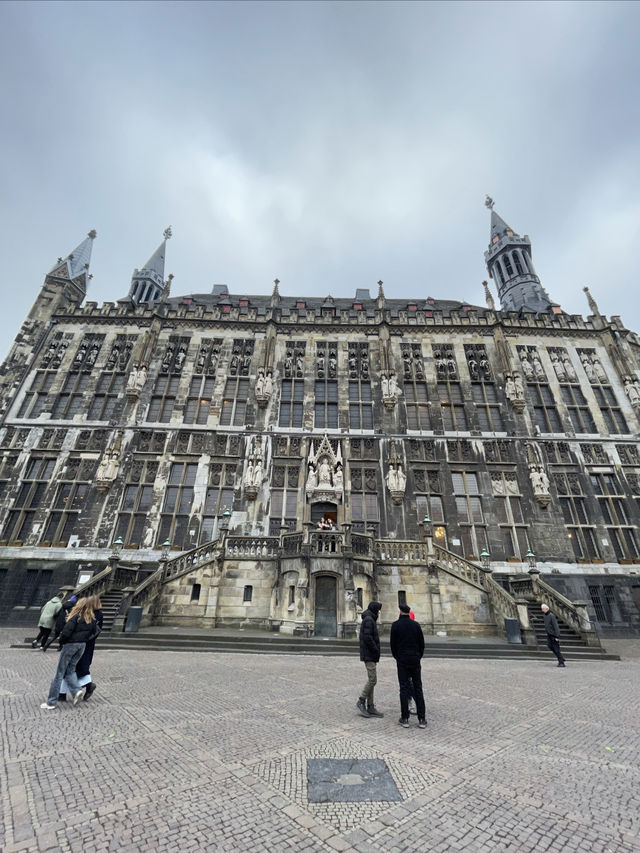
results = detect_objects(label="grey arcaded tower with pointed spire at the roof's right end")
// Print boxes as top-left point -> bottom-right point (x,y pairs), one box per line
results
484,196 -> 554,312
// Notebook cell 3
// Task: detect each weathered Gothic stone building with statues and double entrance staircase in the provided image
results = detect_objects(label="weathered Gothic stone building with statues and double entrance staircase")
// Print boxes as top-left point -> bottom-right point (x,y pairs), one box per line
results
0,211 -> 640,636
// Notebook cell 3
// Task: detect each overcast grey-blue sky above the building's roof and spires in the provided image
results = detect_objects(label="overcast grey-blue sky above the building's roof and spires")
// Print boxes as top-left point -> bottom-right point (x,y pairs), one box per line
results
0,0 -> 640,350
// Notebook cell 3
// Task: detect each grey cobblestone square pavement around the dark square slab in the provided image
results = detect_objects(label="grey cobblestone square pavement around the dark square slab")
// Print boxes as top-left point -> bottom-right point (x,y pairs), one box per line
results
0,629 -> 640,853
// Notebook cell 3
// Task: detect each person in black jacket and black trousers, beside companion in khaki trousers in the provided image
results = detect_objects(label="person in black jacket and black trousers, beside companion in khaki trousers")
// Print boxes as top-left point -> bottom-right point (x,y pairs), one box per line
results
390,604 -> 427,729
